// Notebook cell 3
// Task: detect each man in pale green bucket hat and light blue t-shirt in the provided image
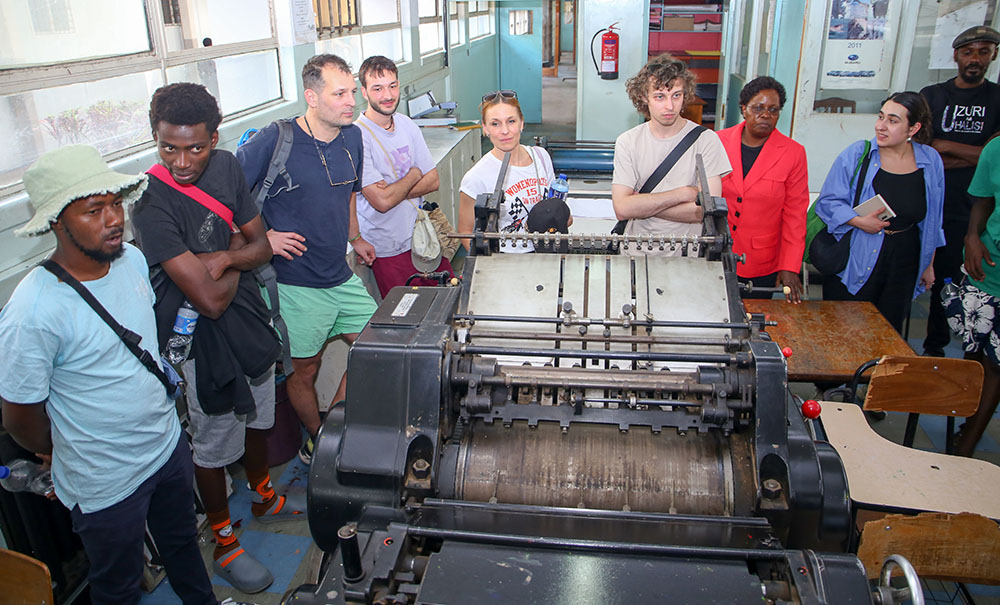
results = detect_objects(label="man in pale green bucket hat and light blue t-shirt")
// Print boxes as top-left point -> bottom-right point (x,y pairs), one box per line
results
0,145 -> 217,604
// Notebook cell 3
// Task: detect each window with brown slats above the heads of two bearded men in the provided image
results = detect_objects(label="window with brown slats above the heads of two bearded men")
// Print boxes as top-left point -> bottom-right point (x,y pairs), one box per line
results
313,0 -> 404,69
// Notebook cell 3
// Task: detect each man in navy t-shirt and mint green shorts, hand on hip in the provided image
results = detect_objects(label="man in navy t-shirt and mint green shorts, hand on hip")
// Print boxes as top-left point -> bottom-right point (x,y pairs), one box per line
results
236,54 -> 376,462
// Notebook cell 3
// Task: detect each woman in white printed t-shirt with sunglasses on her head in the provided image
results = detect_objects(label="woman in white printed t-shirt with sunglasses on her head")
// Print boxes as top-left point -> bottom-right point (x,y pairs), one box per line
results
458,90 -> 555,252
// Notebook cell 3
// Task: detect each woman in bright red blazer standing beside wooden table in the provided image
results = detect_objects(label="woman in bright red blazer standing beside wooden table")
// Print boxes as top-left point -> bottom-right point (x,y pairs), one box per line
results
718,76 -> 809,303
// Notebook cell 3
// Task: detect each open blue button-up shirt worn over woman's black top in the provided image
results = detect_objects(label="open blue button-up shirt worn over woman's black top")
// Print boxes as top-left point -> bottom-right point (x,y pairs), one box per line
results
816,139 -> 944,298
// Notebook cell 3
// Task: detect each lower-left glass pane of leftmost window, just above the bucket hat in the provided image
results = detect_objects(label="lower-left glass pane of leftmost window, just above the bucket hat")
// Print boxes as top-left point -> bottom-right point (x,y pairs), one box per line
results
0,70 -> 162,187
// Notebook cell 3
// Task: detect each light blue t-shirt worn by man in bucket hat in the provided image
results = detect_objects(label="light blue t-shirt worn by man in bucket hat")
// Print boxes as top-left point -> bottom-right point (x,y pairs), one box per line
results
0,244 -> 180,513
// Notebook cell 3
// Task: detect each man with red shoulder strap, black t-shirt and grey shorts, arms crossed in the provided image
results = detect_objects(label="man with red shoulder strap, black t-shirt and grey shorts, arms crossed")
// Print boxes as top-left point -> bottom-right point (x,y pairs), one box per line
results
132,83 -> 304,593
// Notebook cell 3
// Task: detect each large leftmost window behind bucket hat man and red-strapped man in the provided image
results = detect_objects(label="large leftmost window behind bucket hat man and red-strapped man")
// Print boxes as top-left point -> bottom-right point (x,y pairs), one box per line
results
0,0 -> 282,193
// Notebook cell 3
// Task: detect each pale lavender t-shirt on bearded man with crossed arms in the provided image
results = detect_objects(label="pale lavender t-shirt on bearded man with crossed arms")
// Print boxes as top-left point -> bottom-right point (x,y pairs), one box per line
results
357,113 -> 435,258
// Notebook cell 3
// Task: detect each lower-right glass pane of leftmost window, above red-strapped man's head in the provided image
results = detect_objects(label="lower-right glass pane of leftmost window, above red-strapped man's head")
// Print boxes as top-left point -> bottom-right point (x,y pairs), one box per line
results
167,50 -> 281,116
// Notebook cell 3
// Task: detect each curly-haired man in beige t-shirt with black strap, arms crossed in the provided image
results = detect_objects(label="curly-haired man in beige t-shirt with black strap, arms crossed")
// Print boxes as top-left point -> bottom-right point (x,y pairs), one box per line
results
611,54 -> 732,255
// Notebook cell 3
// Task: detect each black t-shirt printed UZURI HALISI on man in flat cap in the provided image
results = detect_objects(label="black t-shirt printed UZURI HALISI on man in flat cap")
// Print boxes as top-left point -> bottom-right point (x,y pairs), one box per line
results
920,80 -> 1000,223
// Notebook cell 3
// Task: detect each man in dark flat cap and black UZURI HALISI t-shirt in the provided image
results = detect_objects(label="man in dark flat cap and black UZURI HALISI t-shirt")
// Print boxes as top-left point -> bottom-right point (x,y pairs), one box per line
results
920,25 -> 1000,357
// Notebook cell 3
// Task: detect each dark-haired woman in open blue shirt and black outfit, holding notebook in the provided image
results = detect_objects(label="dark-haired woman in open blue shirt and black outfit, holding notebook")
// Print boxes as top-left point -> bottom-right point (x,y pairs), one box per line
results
816,92 -> 944,332
